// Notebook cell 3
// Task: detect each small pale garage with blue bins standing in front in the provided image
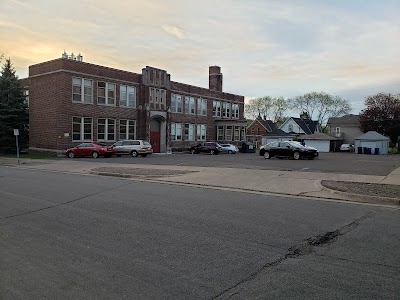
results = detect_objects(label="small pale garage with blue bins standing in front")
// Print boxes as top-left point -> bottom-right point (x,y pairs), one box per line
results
354,131 -> 390,154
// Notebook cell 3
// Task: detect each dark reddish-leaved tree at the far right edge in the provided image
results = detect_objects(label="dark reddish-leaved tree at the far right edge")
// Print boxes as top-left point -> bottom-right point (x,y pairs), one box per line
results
360,93 -> 400,143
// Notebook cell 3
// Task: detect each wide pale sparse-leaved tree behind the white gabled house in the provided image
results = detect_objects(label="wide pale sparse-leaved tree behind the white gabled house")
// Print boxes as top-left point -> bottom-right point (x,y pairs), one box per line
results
290,92 -> 351,125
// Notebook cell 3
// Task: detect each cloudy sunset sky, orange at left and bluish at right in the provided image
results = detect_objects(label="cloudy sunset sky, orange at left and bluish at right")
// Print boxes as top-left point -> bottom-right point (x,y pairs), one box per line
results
0,0 -> 400,114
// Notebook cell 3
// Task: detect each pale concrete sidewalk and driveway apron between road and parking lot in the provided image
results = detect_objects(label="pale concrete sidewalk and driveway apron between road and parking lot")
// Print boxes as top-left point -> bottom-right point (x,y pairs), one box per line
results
0,158 -> 400,206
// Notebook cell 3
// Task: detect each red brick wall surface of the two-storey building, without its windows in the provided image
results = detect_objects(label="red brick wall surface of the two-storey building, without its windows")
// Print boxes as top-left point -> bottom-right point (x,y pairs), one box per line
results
29,59 -> 244,150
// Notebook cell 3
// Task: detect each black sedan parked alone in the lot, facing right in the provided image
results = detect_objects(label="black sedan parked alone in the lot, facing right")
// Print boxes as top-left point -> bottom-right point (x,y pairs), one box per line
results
260,141 -> 318,160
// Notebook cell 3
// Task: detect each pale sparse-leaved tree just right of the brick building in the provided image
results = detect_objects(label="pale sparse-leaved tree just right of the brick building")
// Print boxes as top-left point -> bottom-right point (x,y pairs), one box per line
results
245,96 -> 289,122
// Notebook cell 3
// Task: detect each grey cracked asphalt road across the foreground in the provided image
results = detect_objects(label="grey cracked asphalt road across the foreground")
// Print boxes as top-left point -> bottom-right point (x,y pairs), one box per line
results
0,167 -> 400,300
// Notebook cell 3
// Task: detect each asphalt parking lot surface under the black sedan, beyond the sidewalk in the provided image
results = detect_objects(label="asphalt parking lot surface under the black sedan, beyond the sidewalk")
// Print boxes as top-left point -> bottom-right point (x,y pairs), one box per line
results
65,152 -> 400,176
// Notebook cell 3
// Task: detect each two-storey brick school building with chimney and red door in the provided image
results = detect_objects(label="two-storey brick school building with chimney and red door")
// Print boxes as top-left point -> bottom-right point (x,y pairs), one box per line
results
22,56 -> 246,152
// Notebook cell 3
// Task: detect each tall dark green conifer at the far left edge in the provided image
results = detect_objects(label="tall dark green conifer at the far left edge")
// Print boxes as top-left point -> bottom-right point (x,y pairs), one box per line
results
0,59 -> 29,152
